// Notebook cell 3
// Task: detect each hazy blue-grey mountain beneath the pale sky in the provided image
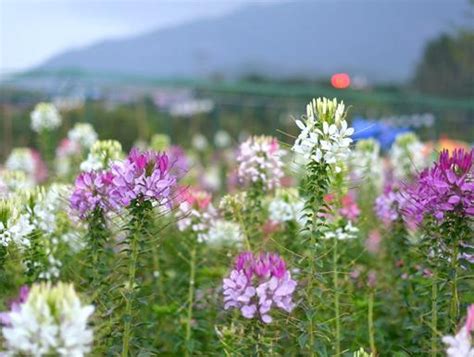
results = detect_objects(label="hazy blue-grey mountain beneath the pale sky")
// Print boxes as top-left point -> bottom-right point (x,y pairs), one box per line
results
37,0 -> 469,81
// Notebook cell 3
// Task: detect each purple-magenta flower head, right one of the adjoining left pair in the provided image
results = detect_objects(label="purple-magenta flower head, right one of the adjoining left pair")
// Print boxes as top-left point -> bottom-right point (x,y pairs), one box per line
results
112,149 -> 176,206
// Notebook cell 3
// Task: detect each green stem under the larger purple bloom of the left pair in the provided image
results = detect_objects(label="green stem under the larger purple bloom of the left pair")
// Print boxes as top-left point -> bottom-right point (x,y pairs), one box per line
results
122,229 -> 138,357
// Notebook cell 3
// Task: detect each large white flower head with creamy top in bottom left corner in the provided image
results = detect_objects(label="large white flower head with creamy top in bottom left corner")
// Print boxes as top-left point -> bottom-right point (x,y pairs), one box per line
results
2,283 -> 94,357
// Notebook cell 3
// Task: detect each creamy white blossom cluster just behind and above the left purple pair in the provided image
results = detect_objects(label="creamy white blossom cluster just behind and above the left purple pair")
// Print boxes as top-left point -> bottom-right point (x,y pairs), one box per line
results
81,140 -> 122,172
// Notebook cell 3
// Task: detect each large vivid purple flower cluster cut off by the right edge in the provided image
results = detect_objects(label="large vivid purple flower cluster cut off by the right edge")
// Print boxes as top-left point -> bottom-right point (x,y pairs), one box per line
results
404,149 -> 474,223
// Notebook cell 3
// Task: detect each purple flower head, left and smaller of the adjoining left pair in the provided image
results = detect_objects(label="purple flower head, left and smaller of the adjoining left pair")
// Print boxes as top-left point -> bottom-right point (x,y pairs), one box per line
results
70,171 -> 118,218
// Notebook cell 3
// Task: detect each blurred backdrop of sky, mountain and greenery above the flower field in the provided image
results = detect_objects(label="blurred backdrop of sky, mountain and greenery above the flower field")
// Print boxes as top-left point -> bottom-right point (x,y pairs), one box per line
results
0,0 -> 474,159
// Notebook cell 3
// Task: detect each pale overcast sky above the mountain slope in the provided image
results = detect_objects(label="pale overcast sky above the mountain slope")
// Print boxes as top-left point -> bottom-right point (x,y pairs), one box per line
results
0,0 -> 278,73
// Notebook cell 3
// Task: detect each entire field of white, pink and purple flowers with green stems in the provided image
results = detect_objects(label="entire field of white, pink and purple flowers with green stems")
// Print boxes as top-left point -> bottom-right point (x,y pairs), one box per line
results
0,98 -> 474,357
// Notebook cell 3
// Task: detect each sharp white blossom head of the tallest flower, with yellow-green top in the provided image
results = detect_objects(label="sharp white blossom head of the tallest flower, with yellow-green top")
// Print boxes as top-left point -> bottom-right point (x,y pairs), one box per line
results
292,98 -> 354,172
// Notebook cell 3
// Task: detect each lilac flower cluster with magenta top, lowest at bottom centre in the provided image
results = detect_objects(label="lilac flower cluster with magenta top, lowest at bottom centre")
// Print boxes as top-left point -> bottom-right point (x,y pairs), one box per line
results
223,252 -> 296,323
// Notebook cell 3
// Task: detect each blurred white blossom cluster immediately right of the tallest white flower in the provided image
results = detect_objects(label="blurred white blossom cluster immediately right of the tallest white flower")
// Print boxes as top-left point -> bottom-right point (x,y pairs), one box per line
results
350,139 -> 383,190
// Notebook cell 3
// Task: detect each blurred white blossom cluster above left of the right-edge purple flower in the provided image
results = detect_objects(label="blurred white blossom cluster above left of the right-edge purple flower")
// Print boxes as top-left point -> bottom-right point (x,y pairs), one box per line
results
390,133 -> 428,180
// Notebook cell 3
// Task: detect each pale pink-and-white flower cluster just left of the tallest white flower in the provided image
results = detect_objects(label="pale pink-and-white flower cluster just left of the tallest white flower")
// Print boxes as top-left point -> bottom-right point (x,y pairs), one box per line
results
237,136 -> 285,191
